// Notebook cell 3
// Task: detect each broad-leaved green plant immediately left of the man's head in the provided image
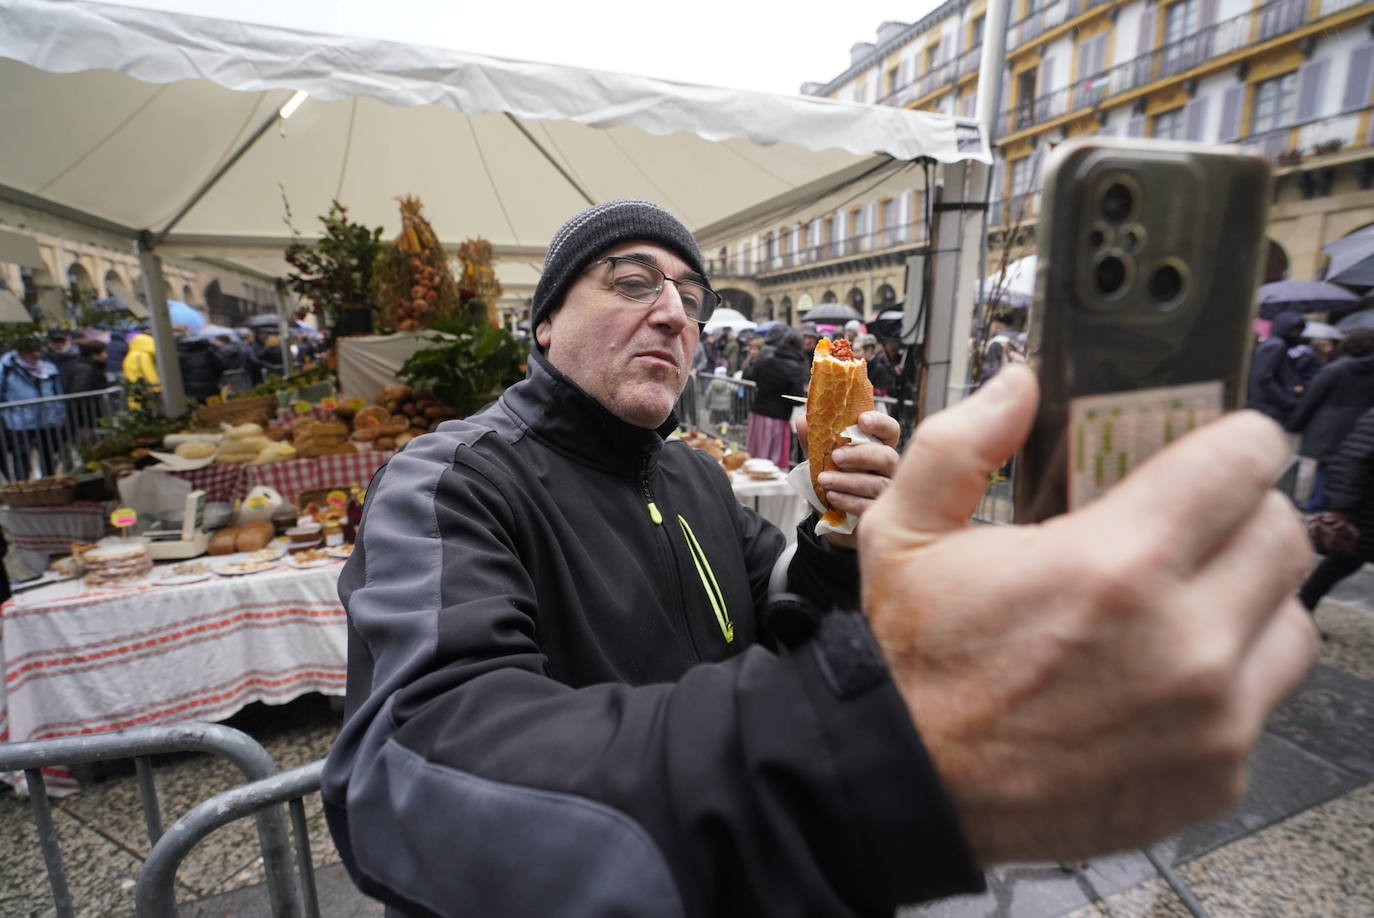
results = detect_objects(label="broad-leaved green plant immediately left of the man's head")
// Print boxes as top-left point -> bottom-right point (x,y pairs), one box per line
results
398,316 -> 528,418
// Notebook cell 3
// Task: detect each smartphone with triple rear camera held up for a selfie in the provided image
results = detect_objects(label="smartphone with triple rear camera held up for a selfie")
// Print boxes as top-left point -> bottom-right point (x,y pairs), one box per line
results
1014,137 -> 1271,522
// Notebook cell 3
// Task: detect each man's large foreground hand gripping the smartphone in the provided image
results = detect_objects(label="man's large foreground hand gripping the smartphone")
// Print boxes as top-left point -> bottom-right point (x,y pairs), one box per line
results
859,366 -> 1318,863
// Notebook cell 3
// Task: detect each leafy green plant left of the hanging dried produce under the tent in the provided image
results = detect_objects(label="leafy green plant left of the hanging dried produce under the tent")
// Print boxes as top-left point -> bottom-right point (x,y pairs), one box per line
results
282,194 -> 383,338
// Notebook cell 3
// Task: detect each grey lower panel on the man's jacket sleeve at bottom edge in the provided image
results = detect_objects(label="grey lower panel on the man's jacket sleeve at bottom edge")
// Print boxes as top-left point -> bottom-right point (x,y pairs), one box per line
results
349,712 -> 683,918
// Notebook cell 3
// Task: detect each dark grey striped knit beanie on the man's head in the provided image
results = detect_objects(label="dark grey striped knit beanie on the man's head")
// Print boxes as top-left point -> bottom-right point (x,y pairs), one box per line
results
530,199 -> 706,330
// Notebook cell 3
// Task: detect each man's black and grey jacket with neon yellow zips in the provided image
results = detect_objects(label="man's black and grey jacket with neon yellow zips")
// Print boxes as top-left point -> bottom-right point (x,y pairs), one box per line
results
323,353 -> 981,918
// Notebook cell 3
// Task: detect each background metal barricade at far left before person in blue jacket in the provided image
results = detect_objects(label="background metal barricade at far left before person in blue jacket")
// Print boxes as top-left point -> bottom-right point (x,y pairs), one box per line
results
0,386 -> 124,482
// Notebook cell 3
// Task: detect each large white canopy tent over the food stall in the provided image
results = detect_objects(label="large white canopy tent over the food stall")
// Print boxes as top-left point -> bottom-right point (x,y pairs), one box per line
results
0,0 -> 991,408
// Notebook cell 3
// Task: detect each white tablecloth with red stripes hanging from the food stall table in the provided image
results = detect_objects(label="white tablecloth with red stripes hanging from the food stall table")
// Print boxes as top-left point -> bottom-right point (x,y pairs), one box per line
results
0,562 -> 346,794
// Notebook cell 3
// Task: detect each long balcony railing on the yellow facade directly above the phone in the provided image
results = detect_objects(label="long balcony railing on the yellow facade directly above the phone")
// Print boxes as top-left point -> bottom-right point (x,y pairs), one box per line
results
1002,0 -> 1356,132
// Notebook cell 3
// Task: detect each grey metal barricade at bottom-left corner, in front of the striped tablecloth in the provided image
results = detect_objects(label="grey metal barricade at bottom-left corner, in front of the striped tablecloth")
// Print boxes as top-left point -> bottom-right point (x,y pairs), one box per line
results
0,723 -> 300,918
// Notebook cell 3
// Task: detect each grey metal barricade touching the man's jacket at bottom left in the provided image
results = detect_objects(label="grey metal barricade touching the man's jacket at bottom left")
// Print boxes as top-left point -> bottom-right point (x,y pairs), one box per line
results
133,759 -> 324,918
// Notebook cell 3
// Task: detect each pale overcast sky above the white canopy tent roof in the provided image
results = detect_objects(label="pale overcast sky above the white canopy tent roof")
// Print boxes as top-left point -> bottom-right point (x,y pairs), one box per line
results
115,0 -> 937,93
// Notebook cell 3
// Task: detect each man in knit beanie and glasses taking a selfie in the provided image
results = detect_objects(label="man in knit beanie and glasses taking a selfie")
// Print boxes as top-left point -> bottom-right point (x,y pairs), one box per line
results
322,201 -> 1312,918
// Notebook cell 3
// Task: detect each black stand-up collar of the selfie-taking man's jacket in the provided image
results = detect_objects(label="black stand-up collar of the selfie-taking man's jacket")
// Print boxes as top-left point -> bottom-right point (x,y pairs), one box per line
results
500,349 -> 677,478
